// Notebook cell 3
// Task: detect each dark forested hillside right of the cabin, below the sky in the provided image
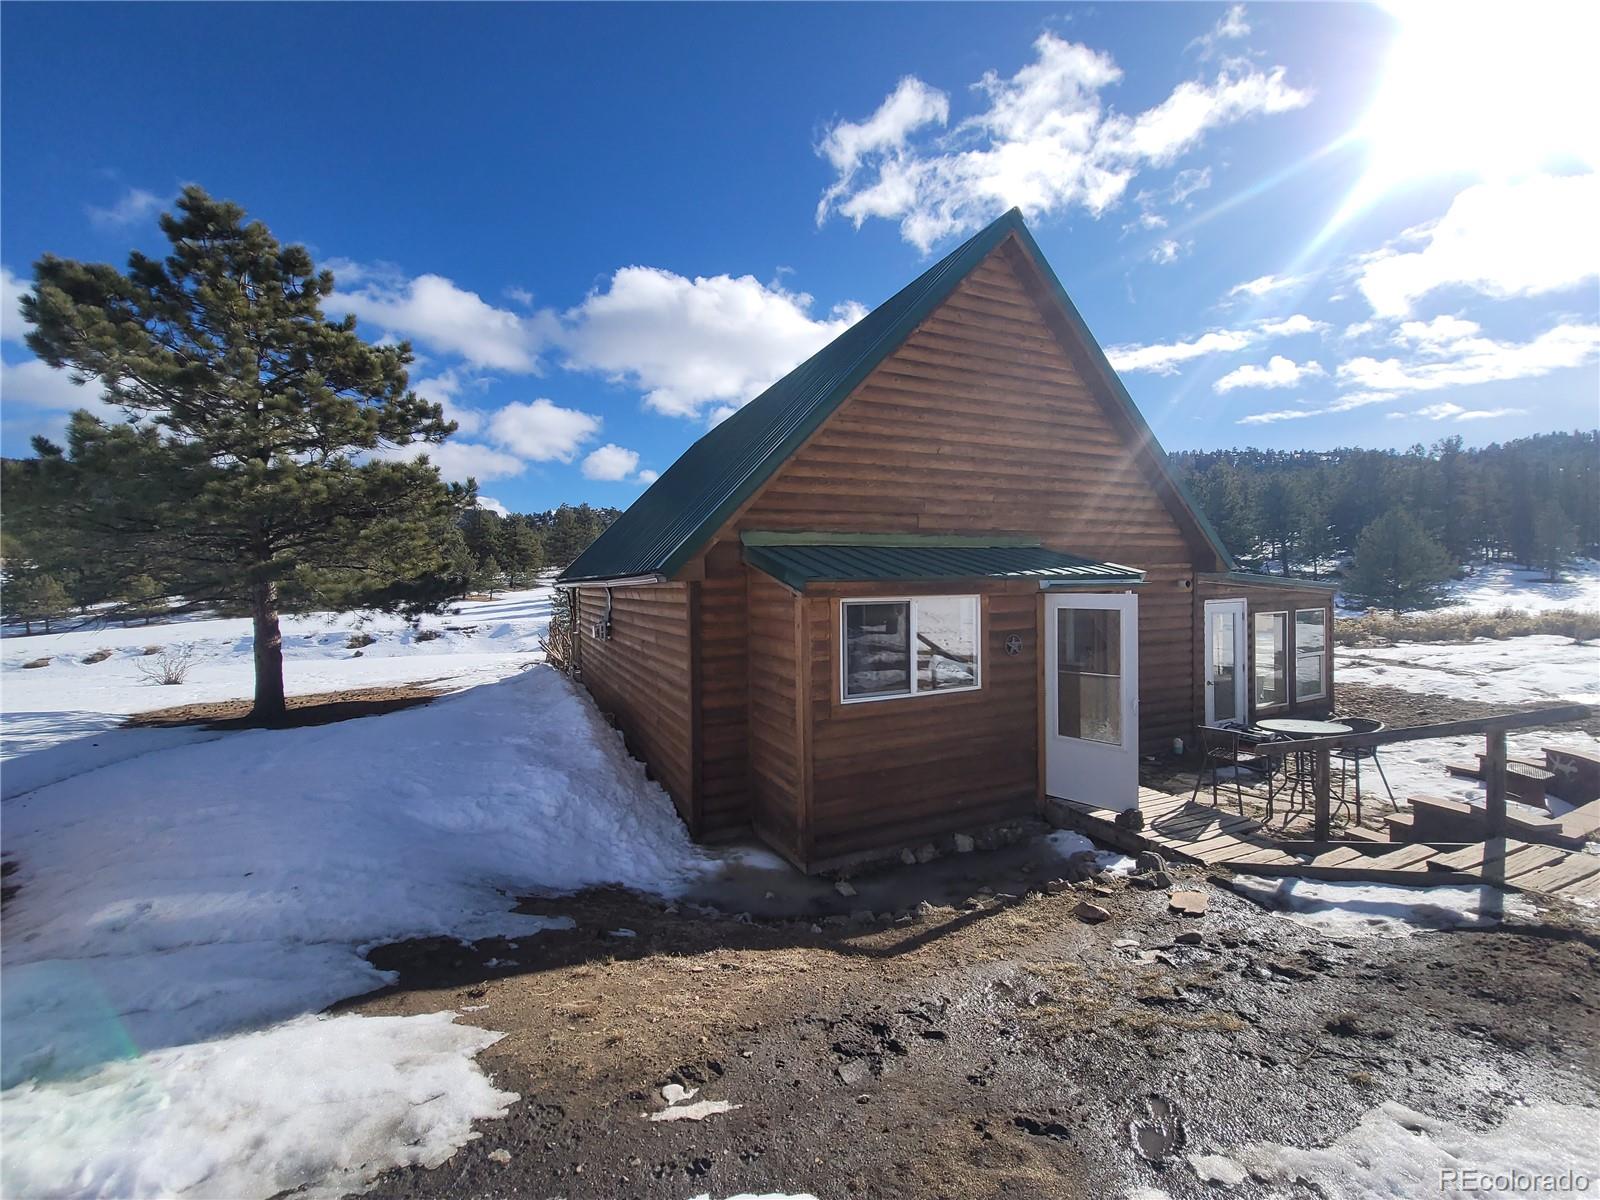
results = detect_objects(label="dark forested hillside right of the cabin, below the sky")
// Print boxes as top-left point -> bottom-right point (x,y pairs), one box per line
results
1171,430 -> 1600,608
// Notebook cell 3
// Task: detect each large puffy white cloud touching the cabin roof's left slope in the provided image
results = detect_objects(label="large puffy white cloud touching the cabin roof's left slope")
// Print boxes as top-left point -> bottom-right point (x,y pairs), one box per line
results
563,267 -> 866,418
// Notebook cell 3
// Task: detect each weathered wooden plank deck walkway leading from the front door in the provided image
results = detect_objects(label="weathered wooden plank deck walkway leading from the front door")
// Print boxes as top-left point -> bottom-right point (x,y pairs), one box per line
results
1050,787 -> 1600,899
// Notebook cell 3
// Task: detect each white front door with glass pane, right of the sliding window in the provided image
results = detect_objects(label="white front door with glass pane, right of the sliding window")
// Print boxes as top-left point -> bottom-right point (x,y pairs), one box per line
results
1045,592 -> 1139,810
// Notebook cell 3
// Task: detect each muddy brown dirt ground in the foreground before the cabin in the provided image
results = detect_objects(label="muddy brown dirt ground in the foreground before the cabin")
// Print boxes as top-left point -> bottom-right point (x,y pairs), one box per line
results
346,840 -> 1600,1200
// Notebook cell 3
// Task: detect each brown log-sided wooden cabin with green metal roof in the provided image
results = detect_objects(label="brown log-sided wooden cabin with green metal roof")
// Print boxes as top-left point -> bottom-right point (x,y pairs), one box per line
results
558,211 -> 1333,870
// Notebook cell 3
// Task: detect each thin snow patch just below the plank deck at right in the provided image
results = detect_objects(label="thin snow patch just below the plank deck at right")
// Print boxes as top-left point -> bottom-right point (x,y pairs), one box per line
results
1234,875 -> 1536,938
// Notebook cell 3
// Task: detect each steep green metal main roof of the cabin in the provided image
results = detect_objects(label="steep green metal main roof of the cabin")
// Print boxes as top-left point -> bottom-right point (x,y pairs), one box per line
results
558,208 -> 1232,582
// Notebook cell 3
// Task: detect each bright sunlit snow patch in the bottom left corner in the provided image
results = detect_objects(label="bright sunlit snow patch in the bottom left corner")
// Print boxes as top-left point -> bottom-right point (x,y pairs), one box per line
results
0,1013 -> 517,1198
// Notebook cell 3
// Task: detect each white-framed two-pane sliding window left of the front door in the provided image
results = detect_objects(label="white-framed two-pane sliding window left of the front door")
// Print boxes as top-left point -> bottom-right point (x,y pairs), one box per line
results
840,595 -> 981,702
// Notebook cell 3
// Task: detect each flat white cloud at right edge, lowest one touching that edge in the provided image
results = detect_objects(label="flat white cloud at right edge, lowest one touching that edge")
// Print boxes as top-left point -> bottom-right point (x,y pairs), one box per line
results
1338,317 -> 1600,395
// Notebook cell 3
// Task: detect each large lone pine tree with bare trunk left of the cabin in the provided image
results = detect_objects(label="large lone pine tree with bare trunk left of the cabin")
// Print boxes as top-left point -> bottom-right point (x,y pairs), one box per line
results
18,187 -> 472,722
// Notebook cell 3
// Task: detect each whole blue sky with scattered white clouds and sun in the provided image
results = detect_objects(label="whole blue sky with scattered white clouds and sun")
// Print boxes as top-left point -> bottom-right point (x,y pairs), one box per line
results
0,3 -> 1600,510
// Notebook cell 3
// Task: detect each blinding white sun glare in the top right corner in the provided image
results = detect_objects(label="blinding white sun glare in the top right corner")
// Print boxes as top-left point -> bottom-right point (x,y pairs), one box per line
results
1333,0 -> 1600,235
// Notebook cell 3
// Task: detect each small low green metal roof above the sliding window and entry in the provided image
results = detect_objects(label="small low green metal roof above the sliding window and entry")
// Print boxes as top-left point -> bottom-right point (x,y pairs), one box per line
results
744,541 -> 1144,592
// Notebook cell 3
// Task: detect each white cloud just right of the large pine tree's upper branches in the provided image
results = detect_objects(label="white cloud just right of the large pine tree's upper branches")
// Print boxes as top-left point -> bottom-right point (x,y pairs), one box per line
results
323,275 -> 554,373
